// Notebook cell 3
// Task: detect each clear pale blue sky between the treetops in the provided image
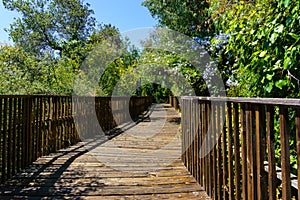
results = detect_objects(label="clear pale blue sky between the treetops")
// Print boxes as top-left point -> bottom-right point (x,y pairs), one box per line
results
0,0 -> 156,42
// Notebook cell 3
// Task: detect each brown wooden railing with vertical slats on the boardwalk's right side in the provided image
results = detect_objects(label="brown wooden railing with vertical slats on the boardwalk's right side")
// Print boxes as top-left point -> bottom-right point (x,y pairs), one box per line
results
181,97 -> 300,199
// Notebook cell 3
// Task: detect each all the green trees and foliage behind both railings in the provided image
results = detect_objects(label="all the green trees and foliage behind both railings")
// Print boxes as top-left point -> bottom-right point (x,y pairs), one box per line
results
0,0 -> 300,195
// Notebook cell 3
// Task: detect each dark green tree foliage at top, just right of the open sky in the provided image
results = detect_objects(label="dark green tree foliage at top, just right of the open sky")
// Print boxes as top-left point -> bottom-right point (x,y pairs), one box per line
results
142,0 -> 213,36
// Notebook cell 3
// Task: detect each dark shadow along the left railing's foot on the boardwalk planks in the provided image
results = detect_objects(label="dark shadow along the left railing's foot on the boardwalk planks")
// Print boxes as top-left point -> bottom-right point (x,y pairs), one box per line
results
0,106 -> 154,199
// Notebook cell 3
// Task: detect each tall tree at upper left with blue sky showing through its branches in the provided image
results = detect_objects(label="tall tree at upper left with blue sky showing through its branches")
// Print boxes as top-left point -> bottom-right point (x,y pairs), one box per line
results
2,0 -> 96,61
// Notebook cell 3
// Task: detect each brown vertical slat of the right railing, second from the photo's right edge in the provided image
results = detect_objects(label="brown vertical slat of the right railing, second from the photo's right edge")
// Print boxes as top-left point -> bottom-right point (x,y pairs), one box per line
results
279,107 -> 291,200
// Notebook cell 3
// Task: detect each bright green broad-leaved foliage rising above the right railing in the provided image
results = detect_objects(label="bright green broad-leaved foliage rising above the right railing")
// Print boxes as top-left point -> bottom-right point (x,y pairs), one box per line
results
215,0 -> 300,97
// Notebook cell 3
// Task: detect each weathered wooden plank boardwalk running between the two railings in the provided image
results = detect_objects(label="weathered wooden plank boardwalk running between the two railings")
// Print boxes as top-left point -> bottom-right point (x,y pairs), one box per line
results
0,105 -> 209,199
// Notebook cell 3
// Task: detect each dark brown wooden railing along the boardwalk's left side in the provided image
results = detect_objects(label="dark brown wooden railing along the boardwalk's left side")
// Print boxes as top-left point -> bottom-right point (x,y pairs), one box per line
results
0,96 -> 153,182
